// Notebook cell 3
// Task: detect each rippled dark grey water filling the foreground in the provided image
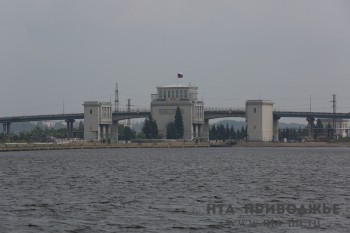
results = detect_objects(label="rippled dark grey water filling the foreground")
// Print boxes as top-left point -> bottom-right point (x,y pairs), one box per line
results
0,147 -> 350,233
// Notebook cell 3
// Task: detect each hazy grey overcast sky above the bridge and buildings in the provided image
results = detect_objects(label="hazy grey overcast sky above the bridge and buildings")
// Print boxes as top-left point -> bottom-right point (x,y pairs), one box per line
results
0,0 -> 350,116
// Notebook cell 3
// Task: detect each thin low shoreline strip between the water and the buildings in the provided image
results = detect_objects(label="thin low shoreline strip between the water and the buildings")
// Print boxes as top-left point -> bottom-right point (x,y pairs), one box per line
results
0,142 -> 350,152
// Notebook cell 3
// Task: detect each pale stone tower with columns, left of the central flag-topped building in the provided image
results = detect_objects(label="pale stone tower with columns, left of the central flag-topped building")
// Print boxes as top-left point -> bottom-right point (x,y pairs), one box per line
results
84,101 -> 112,141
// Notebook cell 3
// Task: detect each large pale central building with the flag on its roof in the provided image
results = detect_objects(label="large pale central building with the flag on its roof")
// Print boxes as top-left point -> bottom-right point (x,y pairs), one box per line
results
151,85 -> 204,140
